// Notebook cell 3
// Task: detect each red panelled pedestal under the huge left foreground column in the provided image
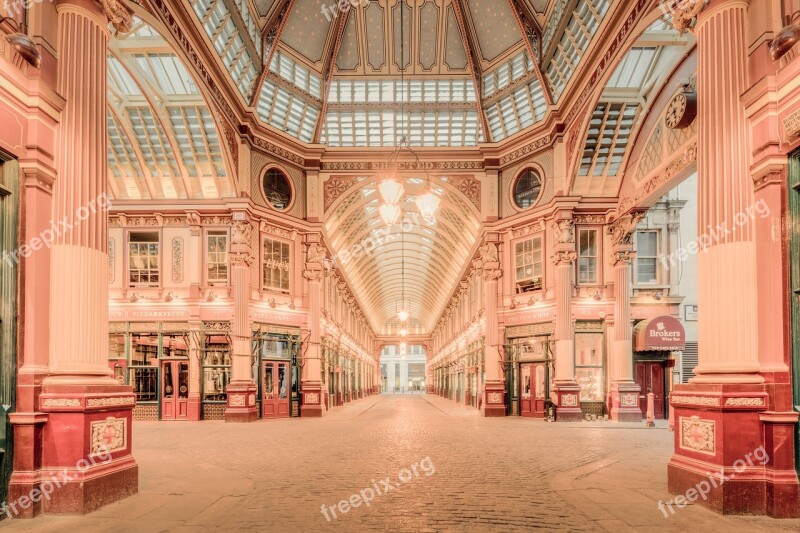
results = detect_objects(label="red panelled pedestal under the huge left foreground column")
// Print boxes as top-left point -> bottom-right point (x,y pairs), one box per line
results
7,385 -> 139,518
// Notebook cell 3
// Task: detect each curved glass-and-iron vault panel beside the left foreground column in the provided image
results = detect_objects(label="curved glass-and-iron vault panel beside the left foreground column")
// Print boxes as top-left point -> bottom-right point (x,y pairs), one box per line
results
107,19 -> 235,200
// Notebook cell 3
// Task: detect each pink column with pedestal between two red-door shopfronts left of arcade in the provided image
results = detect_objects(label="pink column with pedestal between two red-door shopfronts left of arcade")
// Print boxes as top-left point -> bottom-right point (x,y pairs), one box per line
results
225,218 -> 258,422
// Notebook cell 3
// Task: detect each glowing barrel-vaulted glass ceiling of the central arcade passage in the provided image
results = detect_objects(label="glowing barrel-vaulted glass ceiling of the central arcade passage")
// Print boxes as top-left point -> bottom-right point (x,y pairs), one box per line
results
325,178 -> 480,334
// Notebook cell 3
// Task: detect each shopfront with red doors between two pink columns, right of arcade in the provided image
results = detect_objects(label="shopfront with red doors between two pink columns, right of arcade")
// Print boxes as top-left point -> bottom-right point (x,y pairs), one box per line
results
503,322 -> 555,418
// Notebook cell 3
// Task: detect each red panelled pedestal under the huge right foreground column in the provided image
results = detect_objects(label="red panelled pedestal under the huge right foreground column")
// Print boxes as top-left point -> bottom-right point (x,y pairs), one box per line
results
667,384 -> 800,518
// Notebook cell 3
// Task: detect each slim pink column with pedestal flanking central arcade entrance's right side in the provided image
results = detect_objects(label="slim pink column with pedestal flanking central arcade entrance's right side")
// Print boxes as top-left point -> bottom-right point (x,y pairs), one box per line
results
476,233 -> 506,416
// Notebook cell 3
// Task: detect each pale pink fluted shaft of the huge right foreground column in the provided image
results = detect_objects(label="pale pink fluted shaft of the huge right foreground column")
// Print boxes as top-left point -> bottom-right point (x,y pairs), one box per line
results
693,0 -> 763,383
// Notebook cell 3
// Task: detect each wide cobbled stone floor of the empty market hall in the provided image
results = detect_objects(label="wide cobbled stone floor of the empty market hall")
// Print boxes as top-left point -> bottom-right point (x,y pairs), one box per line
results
0,395 -> 800,533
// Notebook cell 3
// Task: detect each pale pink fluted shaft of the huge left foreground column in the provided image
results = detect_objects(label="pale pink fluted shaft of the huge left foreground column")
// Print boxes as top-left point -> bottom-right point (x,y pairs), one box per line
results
45,2 -> 114,384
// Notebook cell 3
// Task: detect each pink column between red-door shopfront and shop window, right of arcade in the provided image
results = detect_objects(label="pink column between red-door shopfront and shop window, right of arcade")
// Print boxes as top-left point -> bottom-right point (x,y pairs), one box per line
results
550,214 -> 581,422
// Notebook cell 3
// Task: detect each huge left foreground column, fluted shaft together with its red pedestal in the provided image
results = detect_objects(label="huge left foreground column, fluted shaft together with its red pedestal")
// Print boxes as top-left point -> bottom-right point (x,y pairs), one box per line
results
31,0 -> 138,513
